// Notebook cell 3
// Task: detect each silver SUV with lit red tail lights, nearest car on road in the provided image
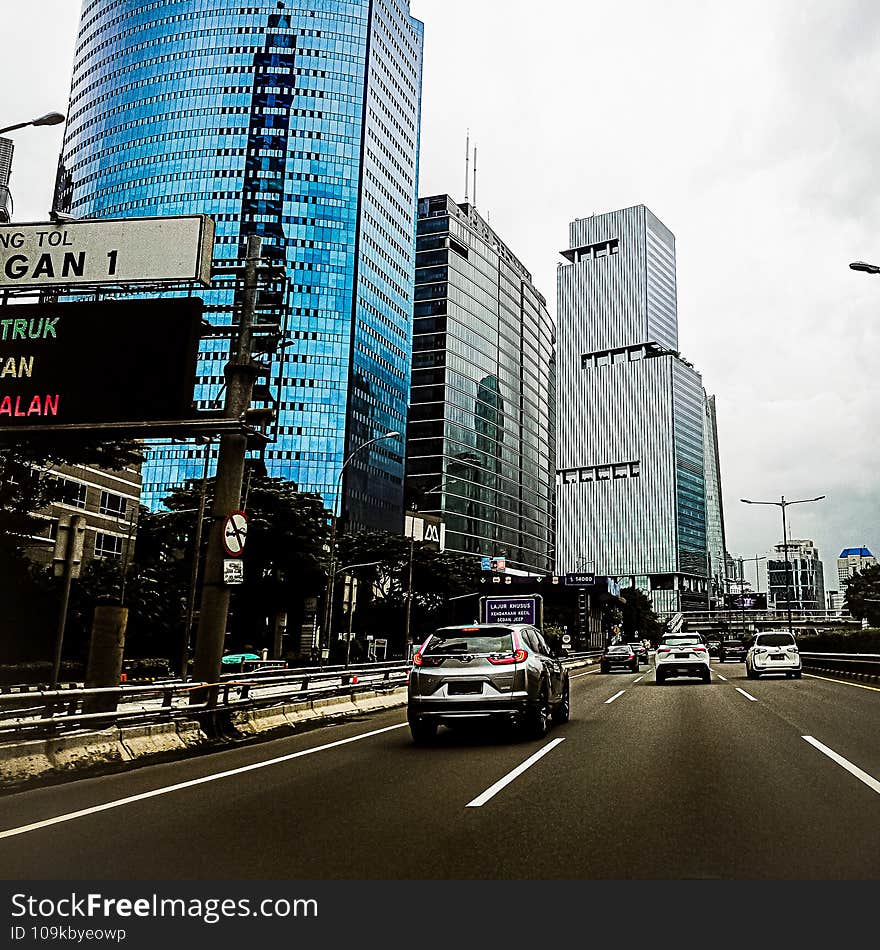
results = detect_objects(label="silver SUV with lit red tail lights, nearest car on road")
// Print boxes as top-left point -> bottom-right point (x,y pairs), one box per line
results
407,623 -> 570,743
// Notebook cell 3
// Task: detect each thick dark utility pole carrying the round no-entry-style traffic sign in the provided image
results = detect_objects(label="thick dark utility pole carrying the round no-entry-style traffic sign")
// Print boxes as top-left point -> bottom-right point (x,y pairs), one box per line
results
190,234 -> 263,706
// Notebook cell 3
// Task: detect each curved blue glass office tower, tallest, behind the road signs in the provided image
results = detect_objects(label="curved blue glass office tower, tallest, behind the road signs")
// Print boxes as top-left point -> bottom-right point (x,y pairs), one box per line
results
56,0 -> 423,530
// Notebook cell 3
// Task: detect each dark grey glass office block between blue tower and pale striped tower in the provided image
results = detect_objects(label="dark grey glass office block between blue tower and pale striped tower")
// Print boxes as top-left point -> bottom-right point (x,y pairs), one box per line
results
407,195 -> 556,574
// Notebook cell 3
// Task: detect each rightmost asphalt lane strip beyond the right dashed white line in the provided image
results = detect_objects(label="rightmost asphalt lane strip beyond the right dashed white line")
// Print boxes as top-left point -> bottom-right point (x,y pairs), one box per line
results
716,666 -> 880,779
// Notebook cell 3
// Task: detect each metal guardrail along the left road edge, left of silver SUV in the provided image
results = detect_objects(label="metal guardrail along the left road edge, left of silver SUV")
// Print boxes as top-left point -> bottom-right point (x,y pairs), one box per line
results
0,650 -> 602,740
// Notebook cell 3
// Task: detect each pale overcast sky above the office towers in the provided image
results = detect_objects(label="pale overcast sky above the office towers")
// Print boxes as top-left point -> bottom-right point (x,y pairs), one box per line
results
0,0 -> 880,590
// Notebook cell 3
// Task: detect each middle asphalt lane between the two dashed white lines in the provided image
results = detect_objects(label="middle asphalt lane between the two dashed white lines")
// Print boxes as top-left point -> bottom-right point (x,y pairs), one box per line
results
447,677 -> 880,880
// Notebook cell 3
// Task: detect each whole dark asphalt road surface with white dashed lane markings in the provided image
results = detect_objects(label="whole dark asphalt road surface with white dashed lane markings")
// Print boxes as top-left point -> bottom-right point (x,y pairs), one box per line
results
0,663 -> 880,880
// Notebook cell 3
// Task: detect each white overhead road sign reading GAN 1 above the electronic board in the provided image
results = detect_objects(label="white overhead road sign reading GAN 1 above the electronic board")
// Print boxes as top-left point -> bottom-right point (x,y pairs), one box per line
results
0,214 -> 214,290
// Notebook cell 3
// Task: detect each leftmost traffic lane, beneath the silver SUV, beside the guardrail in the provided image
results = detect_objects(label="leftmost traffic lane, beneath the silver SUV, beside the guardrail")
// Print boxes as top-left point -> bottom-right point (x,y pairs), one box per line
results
0,681 -> 604,880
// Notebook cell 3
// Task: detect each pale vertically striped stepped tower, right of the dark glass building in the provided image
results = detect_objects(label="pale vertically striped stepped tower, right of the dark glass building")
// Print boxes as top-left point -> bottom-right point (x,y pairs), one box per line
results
556,205 -> 723,612
